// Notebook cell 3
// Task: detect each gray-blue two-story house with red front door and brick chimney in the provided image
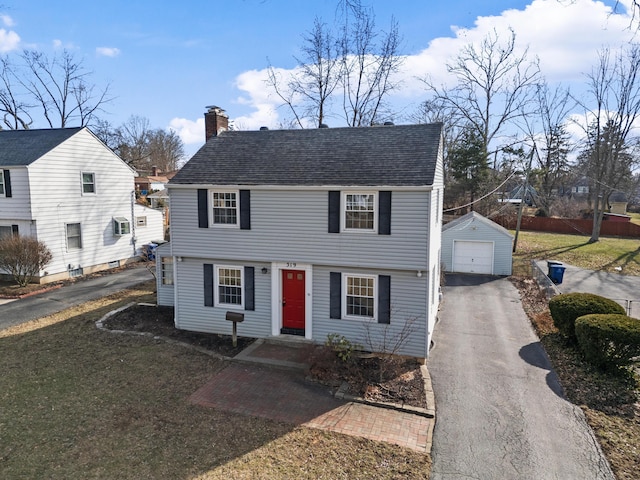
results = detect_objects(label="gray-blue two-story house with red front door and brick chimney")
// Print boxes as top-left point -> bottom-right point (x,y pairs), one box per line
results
157,107 -> 443,358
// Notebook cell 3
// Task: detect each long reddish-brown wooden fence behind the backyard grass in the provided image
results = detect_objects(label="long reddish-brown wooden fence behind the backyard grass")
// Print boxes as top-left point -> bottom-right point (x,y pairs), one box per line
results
491,216 -> 640,238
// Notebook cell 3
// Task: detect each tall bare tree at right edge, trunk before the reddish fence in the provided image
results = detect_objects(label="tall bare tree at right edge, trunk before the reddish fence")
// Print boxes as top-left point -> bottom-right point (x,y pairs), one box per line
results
577,45 -> 640,243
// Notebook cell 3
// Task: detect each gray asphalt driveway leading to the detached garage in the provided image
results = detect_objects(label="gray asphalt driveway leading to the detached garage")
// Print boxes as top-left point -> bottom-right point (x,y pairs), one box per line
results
428,275 -> 614,480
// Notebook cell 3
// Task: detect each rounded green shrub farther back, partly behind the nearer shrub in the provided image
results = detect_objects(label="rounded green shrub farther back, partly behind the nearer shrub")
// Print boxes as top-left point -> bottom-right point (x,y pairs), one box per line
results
549,293 -> 626,340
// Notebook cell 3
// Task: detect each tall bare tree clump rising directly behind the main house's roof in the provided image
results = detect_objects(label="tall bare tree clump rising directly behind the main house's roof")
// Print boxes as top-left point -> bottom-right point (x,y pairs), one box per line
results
267,0 -> 402,128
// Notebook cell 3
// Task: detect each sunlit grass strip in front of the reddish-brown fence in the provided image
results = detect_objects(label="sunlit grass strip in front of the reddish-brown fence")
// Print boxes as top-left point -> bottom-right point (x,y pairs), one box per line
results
513,232 -> 640,275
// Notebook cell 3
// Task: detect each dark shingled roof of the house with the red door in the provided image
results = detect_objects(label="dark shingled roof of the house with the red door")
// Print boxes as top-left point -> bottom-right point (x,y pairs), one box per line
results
169,123 -> 442,186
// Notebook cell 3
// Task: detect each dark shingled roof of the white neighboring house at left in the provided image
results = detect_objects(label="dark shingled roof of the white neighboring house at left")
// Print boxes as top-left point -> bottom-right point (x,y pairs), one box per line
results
0,127 -> 83,167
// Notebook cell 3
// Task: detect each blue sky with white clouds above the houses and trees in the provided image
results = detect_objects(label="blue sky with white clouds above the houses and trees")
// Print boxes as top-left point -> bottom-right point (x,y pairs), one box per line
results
0,0 -> 633,157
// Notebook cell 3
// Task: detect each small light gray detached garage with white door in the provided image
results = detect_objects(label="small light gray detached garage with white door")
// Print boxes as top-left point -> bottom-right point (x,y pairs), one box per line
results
441,212 -> 513,275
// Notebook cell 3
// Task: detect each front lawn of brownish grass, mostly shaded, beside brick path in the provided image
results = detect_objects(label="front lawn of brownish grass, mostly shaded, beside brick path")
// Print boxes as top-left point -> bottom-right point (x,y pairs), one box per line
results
0,283 -> 430,480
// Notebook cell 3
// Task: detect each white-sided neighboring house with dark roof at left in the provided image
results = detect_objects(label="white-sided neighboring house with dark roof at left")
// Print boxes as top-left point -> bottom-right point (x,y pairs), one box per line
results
0,128 -> 164,283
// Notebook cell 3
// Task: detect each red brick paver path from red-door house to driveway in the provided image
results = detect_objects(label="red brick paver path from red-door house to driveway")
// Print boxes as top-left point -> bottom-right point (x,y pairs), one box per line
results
190,363 -> 432,452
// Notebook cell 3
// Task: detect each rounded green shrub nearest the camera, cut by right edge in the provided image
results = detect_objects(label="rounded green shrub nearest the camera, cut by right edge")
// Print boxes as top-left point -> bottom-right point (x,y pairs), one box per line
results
576,314 -> 640,369
